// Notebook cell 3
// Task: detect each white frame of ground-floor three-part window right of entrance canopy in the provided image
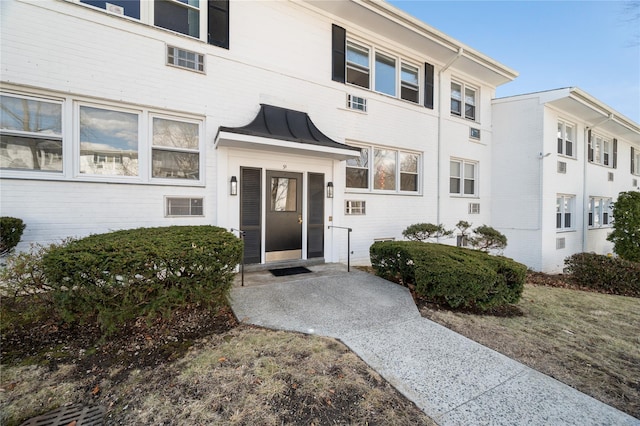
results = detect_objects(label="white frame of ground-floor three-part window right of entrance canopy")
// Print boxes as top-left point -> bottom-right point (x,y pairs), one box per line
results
345,145 -> 423,195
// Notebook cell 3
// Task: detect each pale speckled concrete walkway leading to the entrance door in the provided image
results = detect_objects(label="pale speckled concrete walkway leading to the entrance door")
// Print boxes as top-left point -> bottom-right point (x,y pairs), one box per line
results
231,264 -> 640,426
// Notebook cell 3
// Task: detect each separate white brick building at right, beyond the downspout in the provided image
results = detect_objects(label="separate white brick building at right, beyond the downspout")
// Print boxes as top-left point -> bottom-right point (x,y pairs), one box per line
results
491,87 -> 640,272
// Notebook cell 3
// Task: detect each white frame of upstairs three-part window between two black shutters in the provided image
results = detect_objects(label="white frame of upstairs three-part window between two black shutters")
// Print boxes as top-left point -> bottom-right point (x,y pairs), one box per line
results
345,38 -> 424,105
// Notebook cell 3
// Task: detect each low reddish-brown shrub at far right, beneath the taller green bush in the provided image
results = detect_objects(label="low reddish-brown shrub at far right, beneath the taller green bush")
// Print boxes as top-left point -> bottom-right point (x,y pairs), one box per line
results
564,253 -> 640,297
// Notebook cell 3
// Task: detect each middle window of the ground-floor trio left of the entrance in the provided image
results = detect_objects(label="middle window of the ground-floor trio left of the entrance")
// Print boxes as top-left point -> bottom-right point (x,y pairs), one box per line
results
79,105 -> 139,176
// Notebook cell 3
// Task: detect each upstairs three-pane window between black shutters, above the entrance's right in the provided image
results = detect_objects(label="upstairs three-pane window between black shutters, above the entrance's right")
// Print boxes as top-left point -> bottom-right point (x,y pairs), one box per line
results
342,39 -> 422,103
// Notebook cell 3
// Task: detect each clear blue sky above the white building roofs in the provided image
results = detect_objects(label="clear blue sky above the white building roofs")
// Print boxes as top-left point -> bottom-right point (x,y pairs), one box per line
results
387,0 -> 640,123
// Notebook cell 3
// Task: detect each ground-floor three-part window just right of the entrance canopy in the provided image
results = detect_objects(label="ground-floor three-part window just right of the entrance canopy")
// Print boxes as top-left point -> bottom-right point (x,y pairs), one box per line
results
346,147 -> 420,193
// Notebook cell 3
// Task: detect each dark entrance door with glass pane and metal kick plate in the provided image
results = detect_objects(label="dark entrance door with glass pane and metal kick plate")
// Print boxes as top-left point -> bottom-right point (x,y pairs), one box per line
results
265,170 -> 303,262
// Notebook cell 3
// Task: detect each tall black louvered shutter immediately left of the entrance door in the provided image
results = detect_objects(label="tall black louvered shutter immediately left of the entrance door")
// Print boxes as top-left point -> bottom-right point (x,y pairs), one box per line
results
240,167 -> 262,264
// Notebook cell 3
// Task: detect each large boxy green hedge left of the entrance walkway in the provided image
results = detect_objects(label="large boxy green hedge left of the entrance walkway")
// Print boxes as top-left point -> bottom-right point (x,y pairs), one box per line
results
43,226 -> 243,334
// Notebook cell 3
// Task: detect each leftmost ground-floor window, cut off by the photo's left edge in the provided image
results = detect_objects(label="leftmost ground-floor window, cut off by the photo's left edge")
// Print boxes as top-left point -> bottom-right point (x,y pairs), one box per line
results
0,95 -> 63,173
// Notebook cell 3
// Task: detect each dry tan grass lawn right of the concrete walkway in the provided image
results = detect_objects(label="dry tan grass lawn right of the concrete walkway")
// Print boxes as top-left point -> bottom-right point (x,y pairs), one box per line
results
420,284 -> 640,418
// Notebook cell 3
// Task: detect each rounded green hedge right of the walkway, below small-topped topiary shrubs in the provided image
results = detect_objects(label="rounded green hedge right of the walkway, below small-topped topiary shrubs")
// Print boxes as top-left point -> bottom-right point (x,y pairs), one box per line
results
370,241 -> 527,310
